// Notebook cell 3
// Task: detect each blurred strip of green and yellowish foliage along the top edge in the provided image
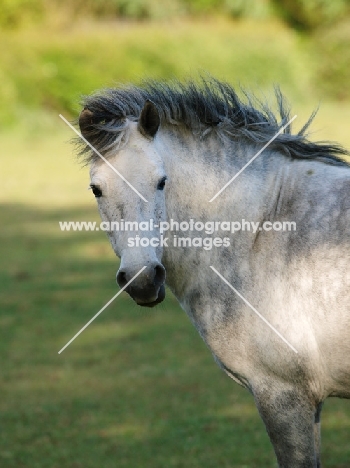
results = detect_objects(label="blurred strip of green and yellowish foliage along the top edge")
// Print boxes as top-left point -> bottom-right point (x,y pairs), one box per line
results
0,0 -> 350,26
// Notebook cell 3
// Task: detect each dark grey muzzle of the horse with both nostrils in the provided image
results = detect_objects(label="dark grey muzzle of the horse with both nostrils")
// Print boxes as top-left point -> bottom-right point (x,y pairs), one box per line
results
117,263 -> 165,307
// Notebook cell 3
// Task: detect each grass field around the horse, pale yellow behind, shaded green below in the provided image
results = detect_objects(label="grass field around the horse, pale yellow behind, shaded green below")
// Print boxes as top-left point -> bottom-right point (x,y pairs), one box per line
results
0,17 -> 350,468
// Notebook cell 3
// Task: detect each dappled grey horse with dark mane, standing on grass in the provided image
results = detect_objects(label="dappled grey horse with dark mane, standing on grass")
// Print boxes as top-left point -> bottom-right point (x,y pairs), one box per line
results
79,78 -> 350,468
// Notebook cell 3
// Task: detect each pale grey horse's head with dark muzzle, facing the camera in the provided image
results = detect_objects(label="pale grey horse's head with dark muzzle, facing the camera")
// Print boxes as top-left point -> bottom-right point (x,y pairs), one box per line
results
80,103 -> 167,307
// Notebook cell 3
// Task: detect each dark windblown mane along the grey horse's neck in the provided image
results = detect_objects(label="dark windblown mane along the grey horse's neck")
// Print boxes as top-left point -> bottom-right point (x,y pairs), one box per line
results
80,78 -> 349,165
